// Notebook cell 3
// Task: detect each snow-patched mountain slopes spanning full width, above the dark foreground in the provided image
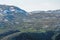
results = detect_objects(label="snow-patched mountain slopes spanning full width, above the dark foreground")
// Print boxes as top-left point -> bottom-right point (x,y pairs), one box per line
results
0,5 -> 60,31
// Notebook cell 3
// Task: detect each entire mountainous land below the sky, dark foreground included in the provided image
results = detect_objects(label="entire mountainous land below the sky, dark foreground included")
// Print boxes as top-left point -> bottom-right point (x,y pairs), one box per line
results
0,5 -> 60,40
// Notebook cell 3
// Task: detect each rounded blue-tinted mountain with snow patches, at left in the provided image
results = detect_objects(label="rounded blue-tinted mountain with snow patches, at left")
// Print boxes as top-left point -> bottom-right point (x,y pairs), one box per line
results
0,5 -> 28,29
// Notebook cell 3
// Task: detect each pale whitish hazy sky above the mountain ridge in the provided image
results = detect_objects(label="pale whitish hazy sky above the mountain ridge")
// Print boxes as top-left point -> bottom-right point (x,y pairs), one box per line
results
0,0 -> 60,12
